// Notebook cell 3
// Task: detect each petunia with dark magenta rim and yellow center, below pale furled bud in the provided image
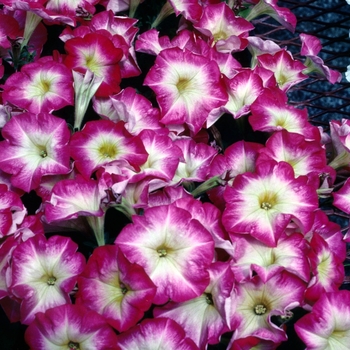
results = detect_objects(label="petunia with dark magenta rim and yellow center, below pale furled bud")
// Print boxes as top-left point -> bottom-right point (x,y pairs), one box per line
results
70,120 -> 147,179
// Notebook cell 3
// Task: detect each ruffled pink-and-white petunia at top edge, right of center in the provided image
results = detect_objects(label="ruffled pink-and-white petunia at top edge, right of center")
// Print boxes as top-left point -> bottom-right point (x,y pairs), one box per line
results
194,2 -> 254,53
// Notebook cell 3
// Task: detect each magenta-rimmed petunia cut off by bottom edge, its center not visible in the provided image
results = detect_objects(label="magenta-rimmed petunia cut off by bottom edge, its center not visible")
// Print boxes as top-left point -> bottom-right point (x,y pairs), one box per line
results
118,318 -> 199,350
